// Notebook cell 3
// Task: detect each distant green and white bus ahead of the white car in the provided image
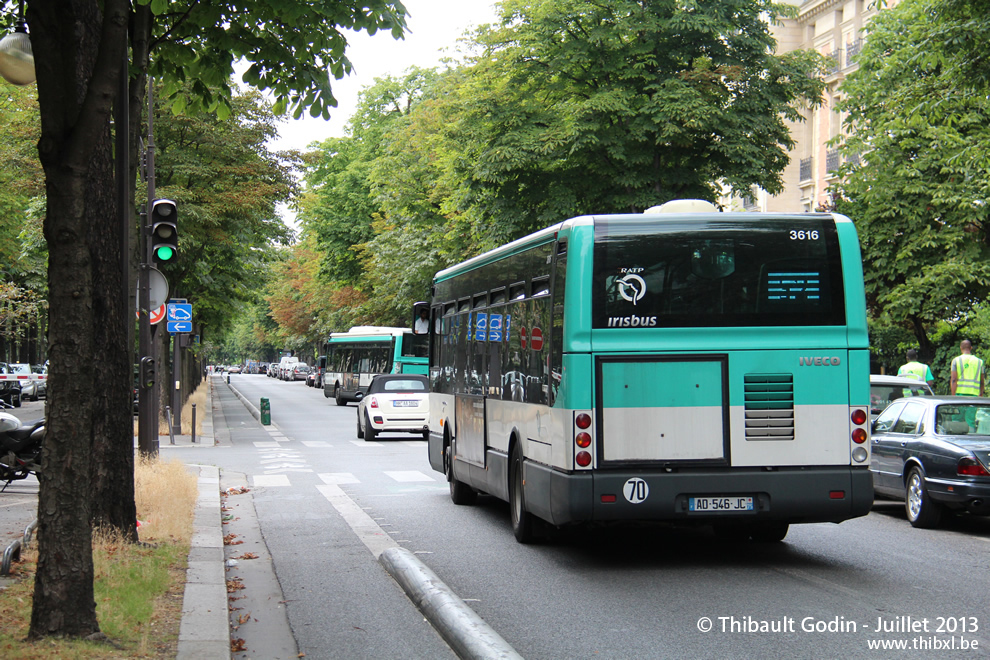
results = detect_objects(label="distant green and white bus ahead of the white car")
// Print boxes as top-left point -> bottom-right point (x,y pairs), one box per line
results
323,326 -> 429,406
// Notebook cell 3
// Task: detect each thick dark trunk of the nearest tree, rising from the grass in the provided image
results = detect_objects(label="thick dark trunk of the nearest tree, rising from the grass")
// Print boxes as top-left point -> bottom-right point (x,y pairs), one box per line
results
27,0 -> 127,639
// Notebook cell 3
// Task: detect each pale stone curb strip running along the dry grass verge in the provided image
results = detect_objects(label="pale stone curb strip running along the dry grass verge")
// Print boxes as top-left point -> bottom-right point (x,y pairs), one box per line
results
175,465 -> 230,660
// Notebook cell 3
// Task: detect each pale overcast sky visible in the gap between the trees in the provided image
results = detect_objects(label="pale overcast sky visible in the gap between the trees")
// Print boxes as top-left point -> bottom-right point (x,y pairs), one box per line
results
269,0 -> 496,150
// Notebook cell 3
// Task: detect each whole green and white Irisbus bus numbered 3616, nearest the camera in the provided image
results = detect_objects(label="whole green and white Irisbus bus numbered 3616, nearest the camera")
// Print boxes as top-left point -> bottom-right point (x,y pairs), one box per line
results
429,200 -> 873,542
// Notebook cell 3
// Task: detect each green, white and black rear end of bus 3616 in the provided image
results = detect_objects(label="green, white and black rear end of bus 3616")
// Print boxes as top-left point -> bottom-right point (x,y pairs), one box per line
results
556,204 -> 873,530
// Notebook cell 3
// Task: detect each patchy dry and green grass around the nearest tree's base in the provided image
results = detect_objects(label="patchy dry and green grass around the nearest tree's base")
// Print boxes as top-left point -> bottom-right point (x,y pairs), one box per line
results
0,459 -> 198,660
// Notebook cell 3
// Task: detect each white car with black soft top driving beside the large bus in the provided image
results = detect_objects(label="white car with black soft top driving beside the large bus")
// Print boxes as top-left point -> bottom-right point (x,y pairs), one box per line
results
357,374 -> 430,441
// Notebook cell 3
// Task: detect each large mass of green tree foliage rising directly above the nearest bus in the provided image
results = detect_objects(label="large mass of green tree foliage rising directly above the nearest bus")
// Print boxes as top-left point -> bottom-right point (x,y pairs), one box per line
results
280,0 -> 823,340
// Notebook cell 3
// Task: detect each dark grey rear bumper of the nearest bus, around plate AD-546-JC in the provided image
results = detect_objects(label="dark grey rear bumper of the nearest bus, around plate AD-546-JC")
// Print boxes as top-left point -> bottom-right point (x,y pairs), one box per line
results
525,463 -> 873,525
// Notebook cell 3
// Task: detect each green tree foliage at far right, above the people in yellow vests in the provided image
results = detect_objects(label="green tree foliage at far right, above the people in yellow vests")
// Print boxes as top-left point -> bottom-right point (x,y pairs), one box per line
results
835,0 -> 990,357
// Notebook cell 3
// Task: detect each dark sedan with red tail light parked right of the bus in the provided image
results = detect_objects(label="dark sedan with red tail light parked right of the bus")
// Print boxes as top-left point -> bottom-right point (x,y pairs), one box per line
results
870,396 -> 990,527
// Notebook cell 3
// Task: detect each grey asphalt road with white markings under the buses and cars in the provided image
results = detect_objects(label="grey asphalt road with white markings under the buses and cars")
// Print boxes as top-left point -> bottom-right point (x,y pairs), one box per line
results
178,375 -> 990,659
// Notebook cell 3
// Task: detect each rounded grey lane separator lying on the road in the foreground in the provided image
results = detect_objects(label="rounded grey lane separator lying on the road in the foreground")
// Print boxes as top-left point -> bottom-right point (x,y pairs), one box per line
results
378,548 -> 522,660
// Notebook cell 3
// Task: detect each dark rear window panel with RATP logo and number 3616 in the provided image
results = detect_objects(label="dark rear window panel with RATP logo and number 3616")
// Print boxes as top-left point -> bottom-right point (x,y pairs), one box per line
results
593,215 -> 845,328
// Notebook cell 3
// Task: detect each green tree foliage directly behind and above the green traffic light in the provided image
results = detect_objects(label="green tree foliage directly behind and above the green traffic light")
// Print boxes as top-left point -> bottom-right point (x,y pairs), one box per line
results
155,85 -> 298,332
